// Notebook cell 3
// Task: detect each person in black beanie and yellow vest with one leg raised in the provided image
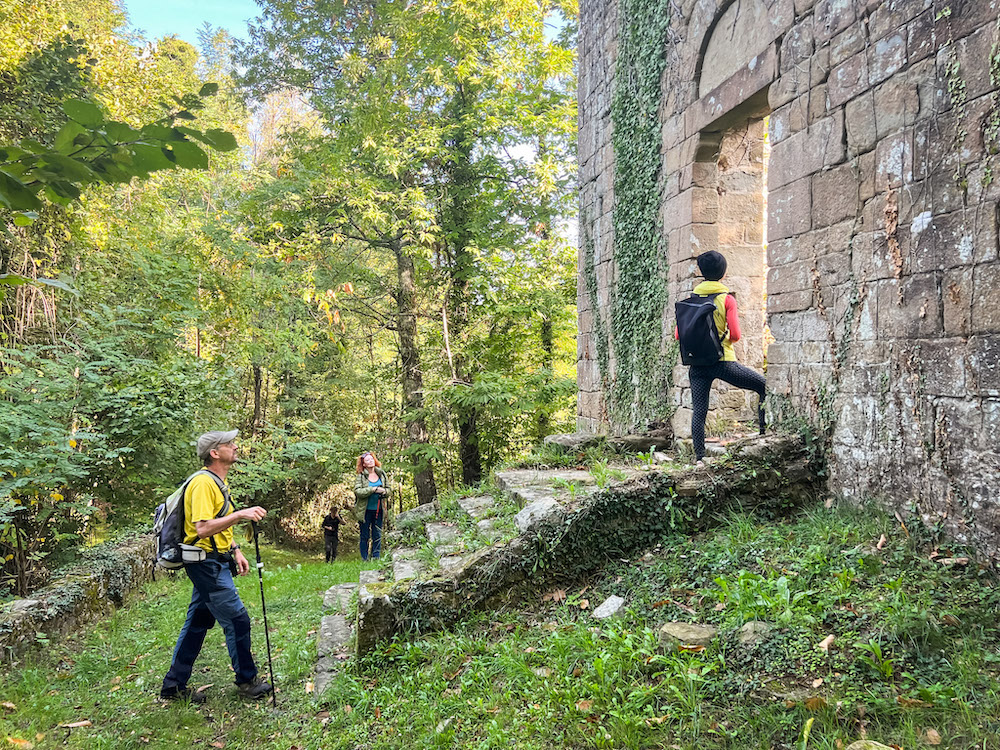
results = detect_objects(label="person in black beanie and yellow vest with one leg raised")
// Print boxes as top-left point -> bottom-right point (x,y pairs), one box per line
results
674,250 -> 766,464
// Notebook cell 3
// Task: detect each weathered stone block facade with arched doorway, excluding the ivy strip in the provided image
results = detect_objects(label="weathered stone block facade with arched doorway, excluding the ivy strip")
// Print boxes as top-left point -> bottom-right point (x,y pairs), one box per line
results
578,0 -> 1000,555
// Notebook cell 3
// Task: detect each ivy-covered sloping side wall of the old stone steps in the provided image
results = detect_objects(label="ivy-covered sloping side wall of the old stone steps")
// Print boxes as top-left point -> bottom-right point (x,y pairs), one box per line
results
358,435 -> 822,653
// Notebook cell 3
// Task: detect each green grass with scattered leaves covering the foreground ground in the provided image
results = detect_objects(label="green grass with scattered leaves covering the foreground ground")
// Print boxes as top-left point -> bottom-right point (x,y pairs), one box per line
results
0,507 -> 1000,750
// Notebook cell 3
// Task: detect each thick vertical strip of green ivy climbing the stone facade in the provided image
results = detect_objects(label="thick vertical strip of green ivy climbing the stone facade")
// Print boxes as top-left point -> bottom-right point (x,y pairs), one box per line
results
595,0 -> 673,429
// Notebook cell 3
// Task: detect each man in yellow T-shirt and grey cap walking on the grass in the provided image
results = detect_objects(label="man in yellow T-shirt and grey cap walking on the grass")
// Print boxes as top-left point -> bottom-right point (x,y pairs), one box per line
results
160,430 -> 273,703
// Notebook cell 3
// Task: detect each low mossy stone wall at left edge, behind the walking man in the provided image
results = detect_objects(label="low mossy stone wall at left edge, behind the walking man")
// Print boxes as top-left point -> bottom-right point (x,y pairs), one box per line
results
0,534 -> 154,662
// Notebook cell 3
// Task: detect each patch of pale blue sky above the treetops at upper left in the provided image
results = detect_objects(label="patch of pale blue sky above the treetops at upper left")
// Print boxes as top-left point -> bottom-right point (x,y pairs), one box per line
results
122,0 -> 260,44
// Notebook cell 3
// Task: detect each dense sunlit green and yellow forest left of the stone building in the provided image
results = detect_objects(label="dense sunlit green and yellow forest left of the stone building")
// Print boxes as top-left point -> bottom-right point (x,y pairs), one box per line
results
0,0 -> 576,596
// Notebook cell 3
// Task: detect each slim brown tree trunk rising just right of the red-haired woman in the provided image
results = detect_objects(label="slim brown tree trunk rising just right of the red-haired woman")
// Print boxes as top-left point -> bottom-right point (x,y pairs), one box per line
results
392,240 -> 437,505
